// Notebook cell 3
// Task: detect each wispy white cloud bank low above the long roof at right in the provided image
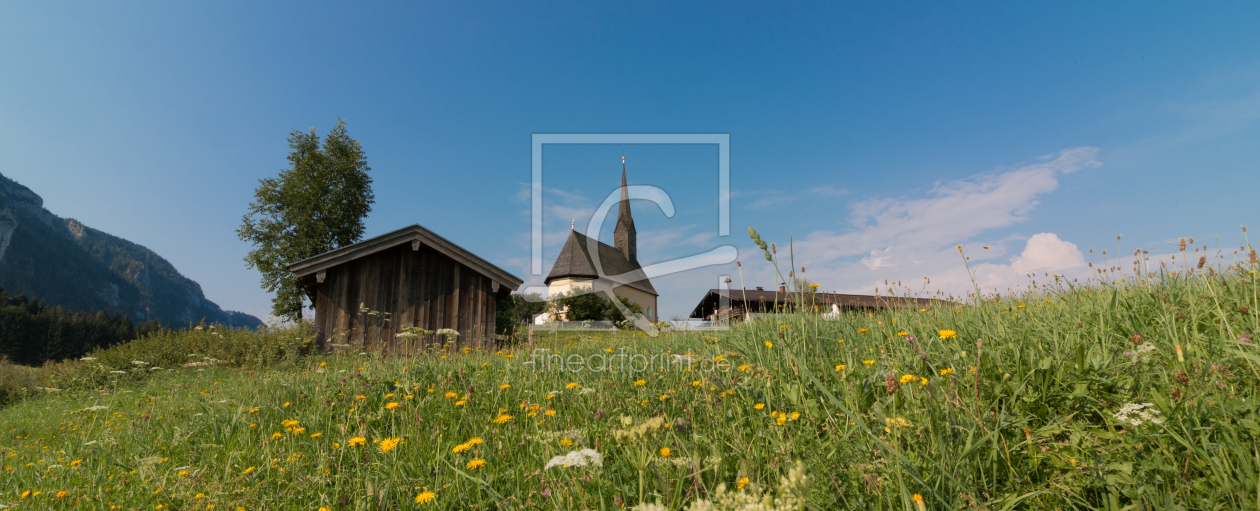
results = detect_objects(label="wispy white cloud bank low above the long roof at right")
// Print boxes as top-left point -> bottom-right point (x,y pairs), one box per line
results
656,147 -> 1101,309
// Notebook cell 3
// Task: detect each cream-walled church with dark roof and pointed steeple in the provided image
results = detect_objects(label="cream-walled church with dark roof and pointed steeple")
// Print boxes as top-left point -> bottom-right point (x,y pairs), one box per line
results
543,156 -> 659,322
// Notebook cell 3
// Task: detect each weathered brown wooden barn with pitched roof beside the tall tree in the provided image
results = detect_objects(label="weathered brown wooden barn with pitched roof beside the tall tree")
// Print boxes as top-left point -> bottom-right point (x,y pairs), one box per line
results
289,225 -> 522,355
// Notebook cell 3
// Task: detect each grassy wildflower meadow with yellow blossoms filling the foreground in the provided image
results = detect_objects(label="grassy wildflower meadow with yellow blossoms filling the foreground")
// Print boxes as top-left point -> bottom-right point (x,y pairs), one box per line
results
0,258 -> 1260,511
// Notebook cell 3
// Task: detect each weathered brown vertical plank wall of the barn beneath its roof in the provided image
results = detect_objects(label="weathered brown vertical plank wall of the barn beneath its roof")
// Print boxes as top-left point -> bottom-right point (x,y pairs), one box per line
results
315,244 -> 496,355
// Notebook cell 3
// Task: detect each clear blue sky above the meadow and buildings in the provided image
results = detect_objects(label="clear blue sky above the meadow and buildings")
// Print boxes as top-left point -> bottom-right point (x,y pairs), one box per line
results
0,3 -> 1260,317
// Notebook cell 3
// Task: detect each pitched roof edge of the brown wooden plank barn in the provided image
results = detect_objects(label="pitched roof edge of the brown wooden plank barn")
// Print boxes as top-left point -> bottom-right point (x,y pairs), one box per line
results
289,224 -> 524,289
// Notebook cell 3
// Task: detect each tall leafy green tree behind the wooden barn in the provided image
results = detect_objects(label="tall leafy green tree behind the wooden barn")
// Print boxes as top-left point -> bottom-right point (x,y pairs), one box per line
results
237,118 -> 375,320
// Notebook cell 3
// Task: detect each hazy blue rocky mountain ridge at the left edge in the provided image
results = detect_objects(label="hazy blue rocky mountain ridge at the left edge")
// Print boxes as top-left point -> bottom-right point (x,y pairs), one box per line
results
0,175 -> 262,327
